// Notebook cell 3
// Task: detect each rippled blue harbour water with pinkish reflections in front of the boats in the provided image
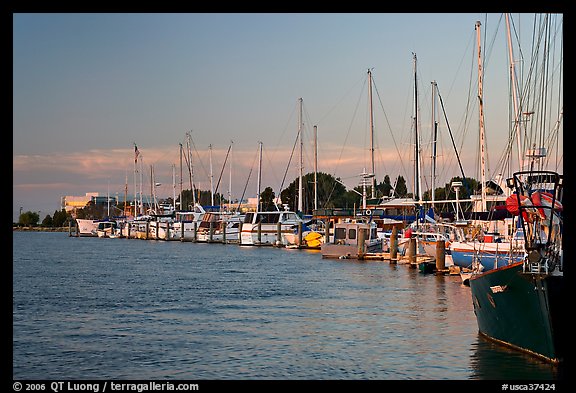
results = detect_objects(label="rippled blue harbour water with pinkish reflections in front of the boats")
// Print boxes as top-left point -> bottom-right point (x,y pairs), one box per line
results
12,232 -> 561,380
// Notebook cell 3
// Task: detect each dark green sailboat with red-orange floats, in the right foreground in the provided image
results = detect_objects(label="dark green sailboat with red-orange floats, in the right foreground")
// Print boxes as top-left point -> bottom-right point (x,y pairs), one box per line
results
470,15 -> 570,364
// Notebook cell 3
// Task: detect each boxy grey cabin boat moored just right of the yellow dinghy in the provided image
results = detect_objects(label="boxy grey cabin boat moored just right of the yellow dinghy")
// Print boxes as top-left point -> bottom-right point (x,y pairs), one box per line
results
320,219 -> 382,259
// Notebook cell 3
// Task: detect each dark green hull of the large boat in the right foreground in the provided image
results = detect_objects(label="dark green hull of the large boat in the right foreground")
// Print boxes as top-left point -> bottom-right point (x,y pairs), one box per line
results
469,262 -> 567,363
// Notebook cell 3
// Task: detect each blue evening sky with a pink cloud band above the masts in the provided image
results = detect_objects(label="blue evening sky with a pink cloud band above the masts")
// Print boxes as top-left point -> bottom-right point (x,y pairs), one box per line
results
12,13 -> 562,221
